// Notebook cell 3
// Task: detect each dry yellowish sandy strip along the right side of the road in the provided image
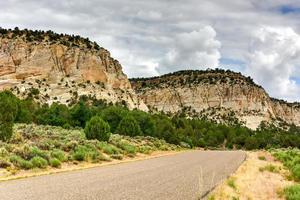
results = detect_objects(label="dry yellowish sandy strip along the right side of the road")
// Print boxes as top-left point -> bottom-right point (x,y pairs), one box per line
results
210,151 -> 293,200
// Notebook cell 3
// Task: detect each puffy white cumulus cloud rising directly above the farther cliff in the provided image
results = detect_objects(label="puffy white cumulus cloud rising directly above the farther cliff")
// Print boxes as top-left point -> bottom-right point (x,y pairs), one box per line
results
159,26 -> 221,73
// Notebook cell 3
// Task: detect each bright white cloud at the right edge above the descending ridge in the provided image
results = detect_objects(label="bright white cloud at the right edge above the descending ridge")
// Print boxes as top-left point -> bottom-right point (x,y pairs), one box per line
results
247,26 -> 300,101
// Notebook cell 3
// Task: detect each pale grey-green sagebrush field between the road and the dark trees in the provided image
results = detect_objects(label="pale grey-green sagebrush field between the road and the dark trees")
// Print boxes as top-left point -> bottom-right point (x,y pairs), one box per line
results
0,124 -> 182,170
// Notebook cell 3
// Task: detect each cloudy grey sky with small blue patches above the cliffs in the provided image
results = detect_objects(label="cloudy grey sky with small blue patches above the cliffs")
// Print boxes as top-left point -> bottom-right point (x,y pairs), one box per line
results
0,0 -> 300,102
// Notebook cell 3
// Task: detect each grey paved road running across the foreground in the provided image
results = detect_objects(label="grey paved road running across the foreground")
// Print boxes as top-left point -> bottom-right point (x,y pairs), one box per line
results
0,151 -> 245,200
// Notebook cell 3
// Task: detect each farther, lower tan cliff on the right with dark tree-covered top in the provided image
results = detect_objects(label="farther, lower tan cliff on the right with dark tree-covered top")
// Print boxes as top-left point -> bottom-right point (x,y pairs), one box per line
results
131,70 -> 300,128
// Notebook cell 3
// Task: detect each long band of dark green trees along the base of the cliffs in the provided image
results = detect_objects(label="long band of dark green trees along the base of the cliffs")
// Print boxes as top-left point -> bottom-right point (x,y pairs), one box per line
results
0,91 -> 300,150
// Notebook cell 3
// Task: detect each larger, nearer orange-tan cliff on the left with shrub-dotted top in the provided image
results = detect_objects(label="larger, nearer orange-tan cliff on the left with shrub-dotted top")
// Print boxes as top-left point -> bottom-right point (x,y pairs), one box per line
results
0,29 -> 147,110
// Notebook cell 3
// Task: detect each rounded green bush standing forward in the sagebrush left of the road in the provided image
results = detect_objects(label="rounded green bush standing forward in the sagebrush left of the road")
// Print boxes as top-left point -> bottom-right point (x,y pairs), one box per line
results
84,116 -> 111,141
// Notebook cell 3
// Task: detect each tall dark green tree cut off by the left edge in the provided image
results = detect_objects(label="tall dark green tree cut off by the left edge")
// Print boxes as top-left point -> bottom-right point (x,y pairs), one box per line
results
0,91 -> 18,141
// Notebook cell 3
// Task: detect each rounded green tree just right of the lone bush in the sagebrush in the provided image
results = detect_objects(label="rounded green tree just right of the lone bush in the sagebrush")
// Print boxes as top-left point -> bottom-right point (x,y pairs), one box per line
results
116,115 -> 142,136
